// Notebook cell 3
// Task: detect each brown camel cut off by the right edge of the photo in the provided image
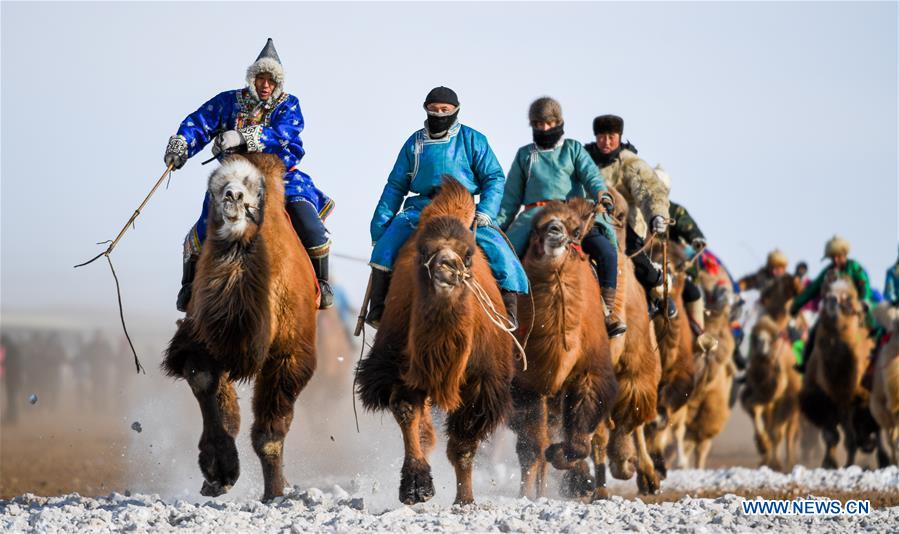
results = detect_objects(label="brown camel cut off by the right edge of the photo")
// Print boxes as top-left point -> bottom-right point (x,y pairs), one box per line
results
870,303 -> 899,465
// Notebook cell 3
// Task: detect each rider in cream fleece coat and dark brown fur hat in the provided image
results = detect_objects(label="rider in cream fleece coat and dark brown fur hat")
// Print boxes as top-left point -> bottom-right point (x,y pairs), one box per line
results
584,115 -> 677,318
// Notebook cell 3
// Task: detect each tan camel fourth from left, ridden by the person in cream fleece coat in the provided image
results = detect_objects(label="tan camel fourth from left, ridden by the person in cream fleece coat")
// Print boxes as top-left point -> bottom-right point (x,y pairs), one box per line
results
588,190 -> 661,499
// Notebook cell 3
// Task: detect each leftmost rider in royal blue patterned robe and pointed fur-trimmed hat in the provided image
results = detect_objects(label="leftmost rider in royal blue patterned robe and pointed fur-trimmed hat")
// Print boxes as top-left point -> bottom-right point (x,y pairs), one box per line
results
165,39 -> 334,311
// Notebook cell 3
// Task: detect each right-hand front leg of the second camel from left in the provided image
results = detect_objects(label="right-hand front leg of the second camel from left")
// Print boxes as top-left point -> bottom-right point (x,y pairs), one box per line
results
446,375 -> 512,504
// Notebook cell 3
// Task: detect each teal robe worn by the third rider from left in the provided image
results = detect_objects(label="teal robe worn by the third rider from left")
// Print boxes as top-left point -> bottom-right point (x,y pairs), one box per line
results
496,139 -> 618,256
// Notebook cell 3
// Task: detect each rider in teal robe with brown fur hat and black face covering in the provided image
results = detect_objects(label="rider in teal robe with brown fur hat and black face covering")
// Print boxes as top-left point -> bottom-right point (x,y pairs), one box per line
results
496,97 -> 627,337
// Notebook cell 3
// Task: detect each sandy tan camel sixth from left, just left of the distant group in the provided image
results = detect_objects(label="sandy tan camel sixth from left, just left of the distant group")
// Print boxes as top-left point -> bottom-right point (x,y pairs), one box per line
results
671,273 -> 736,469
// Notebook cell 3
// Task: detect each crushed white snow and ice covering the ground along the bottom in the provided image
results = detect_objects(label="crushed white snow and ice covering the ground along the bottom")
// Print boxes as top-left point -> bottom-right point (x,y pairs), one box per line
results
0,467 -> 899,532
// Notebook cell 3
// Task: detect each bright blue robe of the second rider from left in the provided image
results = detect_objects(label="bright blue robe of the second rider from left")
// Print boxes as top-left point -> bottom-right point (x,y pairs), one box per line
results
370,123 -> 528,293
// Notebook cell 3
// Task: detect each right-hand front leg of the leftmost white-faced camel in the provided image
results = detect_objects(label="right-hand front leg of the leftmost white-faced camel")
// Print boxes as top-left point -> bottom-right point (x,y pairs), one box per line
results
250,354 -> 315,501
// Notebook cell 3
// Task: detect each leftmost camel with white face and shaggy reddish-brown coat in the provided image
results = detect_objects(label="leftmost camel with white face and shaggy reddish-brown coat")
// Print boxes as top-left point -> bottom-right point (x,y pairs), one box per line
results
162,154 -> 318,500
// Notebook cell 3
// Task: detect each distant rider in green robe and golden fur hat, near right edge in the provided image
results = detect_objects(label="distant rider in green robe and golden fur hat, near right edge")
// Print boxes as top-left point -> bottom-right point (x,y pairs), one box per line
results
790,236 -> 875,373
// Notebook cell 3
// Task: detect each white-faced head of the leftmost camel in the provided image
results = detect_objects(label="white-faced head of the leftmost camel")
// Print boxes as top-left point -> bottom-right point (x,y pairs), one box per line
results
209,157 -> 265,242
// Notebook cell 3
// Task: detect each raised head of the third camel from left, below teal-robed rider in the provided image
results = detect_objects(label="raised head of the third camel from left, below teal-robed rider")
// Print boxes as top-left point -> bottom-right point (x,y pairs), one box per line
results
528,198 -> 597,264
